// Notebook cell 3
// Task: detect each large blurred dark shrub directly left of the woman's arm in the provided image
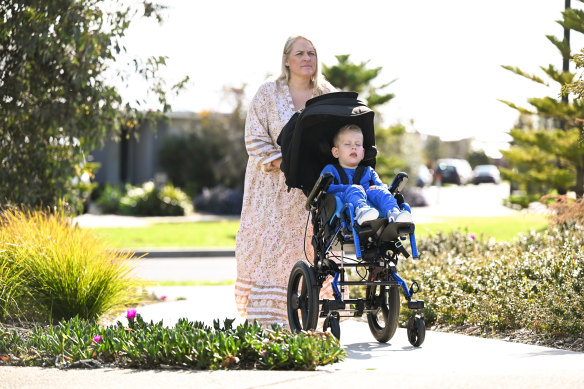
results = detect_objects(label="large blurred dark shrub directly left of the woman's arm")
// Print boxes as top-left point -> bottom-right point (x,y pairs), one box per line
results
158,89 -> 247,197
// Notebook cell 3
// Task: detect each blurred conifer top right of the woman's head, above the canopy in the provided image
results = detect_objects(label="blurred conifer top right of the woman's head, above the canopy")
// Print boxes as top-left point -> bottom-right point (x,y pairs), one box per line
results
322,54 -> 395,113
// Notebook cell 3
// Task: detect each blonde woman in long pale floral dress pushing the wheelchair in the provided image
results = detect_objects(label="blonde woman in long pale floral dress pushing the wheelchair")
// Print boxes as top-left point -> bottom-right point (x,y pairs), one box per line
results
235,36 -> 335,328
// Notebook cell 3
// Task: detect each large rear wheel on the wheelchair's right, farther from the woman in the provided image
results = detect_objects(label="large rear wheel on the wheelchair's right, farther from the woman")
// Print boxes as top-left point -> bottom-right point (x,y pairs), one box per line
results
366,286 -> 401,343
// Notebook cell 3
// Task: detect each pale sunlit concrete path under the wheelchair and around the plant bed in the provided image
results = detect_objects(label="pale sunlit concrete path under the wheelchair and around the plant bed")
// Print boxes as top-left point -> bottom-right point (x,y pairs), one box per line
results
0,285 -> 584,389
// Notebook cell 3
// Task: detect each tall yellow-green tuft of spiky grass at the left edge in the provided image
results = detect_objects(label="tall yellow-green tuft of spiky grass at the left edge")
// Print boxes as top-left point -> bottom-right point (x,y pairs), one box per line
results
0,210 -> 137,322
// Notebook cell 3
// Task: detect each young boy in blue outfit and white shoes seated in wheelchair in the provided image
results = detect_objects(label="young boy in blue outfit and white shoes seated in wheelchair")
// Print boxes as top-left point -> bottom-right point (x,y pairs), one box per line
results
321,124 -> 412,225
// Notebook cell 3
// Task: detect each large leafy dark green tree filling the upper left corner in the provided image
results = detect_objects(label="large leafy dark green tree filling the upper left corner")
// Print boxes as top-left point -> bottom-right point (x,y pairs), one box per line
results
0,0 -> 186,212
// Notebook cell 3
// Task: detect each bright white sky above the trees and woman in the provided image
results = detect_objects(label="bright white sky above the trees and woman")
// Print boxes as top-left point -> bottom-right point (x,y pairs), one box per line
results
124,0 -> 584,157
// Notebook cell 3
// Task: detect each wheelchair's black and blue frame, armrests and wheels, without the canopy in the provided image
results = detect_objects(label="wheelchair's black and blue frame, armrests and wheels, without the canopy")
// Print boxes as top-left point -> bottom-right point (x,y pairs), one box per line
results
287,173 -> 426,347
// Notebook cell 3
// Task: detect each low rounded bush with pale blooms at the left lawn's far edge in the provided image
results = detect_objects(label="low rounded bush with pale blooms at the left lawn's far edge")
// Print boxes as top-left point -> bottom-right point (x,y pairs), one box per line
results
119,181 -> 193,216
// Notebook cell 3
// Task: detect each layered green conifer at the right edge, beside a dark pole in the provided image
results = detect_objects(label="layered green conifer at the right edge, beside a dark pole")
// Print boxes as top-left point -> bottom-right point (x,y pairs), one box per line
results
501,0 -> 584,197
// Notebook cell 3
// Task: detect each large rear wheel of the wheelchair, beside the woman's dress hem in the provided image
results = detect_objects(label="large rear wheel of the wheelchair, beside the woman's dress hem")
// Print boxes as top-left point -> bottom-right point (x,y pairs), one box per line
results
288,261 -> 319,332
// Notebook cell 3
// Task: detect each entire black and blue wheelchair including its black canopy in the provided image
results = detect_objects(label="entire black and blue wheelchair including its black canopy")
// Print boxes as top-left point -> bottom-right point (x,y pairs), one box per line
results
278,92 -> 426,347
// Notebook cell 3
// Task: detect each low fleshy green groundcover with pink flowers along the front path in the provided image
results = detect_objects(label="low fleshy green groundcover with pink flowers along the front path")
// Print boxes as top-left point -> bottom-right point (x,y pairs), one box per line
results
0,314 -> 346,370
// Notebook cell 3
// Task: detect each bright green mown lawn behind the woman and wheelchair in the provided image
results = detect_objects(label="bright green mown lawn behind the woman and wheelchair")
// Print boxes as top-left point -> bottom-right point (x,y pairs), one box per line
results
89,214 -> 547,248
